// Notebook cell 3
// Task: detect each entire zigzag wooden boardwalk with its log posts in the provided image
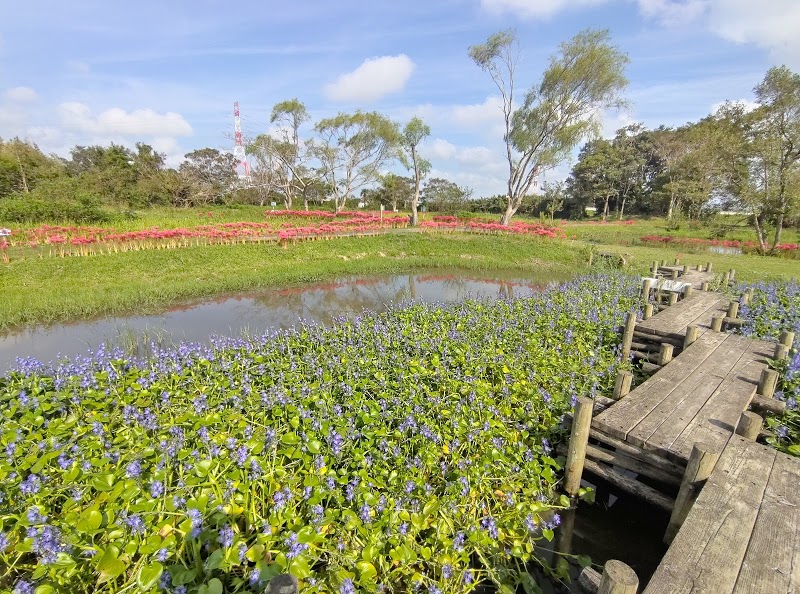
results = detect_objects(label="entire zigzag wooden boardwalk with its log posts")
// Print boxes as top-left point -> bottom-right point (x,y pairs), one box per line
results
565,265 -> 800,594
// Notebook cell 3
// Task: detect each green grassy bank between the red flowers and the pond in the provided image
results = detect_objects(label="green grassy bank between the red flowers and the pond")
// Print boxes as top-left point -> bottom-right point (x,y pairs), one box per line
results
0,232 -> 800,330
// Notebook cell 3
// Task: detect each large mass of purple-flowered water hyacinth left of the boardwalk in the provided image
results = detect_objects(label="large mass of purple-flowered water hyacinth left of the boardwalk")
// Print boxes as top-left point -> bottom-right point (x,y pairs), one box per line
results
0,276 -> 639,593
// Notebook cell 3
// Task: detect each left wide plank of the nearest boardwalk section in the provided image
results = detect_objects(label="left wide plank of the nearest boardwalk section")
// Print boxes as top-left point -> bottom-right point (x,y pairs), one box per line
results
643,435 -> 776,594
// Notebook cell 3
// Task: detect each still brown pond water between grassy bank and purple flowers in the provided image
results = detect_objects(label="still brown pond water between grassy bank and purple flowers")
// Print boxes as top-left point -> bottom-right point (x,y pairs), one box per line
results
0,270 -> 563,373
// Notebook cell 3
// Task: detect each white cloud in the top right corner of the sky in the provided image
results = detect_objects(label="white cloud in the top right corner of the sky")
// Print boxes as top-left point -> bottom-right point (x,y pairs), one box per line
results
709,0 -> 800,68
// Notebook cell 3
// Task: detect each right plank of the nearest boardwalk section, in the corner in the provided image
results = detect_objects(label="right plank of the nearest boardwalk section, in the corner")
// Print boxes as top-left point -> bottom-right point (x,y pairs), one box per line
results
733,453 -> 800,594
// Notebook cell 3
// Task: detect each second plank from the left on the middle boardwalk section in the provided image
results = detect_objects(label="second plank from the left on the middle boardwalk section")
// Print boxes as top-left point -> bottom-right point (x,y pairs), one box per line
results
628,335 -> 750,460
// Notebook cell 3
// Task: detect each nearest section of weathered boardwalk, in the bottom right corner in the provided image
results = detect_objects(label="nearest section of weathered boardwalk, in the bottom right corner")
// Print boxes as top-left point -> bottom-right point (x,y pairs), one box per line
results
644,435 -> 800,594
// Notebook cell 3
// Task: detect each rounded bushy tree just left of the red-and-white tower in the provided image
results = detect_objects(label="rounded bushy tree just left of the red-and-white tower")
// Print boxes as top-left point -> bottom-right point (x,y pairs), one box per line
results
179,148 -> 236,206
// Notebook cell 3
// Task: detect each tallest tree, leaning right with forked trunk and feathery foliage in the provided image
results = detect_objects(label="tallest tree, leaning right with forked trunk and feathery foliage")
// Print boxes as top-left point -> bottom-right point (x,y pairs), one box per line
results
469,30 -> 628,225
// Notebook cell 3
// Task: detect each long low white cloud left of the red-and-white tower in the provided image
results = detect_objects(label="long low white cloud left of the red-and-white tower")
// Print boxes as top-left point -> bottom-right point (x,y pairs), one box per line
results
58,102 -> 192,137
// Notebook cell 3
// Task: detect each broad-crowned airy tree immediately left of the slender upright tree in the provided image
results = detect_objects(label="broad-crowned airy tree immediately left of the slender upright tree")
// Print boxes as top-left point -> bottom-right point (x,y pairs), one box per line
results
314,111 -> 399,213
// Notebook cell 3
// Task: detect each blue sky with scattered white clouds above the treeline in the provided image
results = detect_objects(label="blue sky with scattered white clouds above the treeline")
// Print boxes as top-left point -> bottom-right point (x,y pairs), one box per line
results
0,0 -> 800,196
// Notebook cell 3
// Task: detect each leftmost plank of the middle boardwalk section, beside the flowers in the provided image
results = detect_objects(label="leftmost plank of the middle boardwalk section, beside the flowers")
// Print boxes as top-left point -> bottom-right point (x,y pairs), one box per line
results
592,332 -> 727,440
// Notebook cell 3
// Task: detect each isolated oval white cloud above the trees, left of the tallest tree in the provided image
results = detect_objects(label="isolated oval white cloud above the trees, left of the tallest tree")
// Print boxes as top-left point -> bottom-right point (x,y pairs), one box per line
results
325,54 -> 416,102
